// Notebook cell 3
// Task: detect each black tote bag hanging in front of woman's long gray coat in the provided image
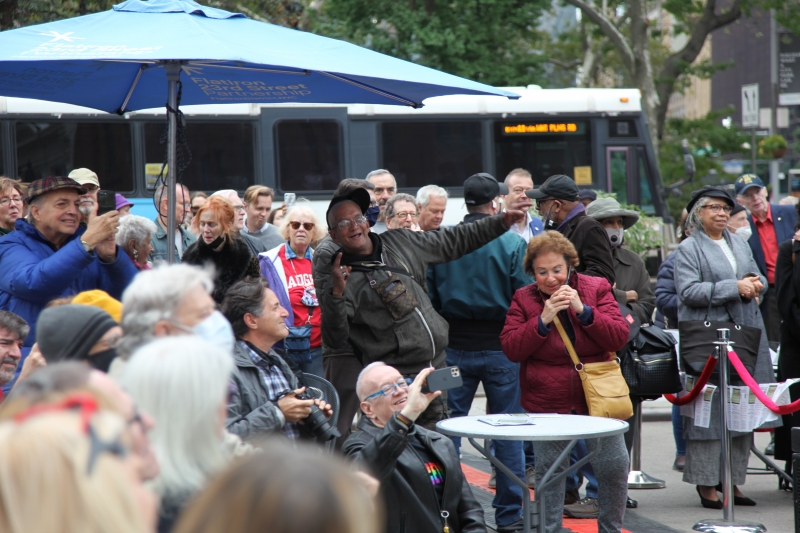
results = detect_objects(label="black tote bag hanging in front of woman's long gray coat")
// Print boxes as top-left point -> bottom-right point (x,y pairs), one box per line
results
678,283 -> 762,385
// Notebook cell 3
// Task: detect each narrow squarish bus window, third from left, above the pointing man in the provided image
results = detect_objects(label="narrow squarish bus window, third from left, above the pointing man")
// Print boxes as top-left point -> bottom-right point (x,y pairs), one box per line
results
275,120 -> 344,191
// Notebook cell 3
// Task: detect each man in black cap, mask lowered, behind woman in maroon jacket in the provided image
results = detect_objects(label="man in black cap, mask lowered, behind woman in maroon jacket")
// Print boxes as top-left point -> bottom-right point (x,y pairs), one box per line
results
525,174 -> 616,286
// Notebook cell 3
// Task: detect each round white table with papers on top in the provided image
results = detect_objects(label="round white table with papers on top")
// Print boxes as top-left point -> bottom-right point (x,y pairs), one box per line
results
436,415 -> 628,533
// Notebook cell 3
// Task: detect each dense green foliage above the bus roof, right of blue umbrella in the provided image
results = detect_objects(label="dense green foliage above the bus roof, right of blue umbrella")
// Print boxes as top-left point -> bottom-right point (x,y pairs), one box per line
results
309,0 -> 549,86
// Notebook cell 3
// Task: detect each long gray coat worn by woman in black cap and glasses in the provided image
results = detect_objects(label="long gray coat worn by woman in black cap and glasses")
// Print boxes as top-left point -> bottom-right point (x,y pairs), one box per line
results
675,229 -> 780,440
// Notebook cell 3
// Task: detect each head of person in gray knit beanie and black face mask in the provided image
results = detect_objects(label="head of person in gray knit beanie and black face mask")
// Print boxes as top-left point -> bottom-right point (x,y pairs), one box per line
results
36,304 -> 122,372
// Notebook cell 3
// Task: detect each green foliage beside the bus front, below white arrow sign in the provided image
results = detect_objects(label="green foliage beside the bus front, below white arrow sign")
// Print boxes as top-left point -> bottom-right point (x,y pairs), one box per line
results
659,108 -> 749,220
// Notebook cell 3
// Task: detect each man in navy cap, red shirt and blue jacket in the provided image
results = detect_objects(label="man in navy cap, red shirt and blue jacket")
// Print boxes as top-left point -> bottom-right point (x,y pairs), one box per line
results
734,174 -> 797,342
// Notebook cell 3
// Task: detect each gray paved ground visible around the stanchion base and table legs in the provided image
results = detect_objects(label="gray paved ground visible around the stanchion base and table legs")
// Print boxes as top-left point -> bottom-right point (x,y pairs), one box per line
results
462,392 -> 795,533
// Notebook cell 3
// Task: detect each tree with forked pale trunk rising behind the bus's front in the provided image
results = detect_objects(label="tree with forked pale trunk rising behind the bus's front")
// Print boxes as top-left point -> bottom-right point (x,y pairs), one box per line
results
564,0 -> 800,151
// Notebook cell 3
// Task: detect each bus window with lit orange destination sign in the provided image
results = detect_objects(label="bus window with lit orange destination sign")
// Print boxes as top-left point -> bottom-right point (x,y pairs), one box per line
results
494,119 -> 592,187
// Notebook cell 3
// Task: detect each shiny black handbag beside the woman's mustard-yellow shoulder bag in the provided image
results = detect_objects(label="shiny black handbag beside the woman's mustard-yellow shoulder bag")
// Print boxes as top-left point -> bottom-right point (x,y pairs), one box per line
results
618,305 -> 683,399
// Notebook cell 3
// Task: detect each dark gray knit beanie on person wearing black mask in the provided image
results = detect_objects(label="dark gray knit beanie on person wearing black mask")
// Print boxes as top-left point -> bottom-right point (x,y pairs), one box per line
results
36,304 -> 118,364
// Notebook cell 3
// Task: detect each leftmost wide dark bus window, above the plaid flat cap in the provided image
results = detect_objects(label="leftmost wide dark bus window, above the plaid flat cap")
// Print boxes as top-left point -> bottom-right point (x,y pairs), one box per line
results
16,122 -> 134,193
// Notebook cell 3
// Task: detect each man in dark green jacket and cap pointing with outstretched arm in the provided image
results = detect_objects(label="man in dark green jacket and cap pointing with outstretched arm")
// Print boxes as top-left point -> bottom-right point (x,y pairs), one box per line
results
320,189 -> 525,429
